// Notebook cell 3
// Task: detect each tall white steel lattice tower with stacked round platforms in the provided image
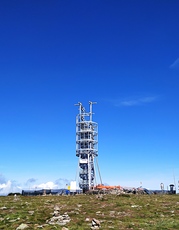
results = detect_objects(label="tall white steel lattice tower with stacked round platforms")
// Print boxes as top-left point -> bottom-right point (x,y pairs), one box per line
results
76,101 -> 98,192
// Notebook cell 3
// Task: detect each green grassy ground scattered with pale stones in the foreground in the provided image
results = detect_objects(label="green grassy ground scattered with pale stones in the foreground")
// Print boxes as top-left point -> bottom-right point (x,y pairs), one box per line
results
0,195 -> 179,230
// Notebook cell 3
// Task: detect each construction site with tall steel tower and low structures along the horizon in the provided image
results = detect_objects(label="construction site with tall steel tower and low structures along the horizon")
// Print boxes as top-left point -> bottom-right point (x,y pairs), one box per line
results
22,101 -> 176,195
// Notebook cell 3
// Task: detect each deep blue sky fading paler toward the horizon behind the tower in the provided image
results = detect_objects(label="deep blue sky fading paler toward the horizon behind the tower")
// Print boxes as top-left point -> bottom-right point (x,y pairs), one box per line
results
0,0 -> 179,193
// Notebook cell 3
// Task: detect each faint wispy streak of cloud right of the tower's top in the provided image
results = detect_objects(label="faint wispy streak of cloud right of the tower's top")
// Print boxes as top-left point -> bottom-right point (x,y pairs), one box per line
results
114,96 -> 158,106
